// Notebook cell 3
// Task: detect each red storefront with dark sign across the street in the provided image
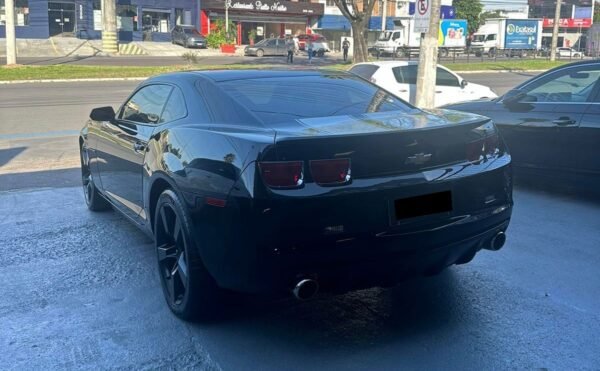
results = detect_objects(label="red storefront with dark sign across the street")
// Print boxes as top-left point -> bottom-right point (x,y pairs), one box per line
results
200,0 -> 324,45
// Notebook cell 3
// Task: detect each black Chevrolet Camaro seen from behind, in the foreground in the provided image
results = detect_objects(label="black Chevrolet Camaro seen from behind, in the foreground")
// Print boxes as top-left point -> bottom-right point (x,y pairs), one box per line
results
79,70 -> 512,319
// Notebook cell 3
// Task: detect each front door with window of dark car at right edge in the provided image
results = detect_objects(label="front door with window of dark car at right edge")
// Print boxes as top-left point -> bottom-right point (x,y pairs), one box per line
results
496,64 -> 600,173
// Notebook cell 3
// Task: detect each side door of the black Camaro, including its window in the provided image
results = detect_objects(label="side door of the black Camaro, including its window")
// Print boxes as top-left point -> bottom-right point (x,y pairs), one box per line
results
96,84 -> 173,222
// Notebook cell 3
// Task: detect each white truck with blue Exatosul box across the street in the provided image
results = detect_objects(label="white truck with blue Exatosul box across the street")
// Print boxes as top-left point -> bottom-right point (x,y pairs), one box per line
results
470,18 -> 542,58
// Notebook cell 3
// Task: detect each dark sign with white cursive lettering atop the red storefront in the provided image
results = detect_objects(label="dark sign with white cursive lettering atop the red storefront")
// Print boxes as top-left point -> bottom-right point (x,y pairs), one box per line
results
201,0 -> 324,15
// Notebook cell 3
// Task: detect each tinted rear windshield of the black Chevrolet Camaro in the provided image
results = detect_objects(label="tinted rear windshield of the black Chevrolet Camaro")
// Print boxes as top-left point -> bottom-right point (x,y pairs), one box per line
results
219,75 -> 413,123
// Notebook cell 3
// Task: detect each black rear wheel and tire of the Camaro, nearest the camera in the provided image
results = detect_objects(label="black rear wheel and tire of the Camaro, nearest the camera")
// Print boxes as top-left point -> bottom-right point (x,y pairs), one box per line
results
154,189 -> 221,321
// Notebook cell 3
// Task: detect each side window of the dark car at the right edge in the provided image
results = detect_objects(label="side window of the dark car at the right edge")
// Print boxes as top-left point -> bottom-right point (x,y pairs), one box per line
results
524,66 -> 600,103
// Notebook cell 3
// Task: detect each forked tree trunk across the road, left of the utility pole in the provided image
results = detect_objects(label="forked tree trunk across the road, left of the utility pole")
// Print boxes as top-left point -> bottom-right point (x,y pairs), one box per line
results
333,0 -> 379,63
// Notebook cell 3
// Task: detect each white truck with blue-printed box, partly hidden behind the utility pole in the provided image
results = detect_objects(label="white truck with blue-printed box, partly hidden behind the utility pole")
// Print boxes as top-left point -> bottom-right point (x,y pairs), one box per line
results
370,17 -> 467,58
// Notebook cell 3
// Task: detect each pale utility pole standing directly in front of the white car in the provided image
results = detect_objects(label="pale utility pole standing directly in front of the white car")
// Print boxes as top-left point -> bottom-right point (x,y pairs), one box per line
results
415,0 -> 441,109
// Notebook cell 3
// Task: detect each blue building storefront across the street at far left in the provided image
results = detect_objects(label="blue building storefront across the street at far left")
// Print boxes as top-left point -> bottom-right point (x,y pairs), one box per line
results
0,0 -> 200,41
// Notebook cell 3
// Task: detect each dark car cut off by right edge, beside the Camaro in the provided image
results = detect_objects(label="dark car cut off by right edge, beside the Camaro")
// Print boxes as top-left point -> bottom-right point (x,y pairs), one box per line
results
446,61 -> 600,188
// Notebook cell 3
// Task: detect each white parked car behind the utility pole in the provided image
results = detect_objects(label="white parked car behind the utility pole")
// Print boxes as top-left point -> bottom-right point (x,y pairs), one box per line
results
350,61 -> 498,107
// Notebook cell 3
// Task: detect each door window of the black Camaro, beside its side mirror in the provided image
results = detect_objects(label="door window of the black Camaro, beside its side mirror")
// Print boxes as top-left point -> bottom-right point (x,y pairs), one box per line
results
119,85 -> 173,124
